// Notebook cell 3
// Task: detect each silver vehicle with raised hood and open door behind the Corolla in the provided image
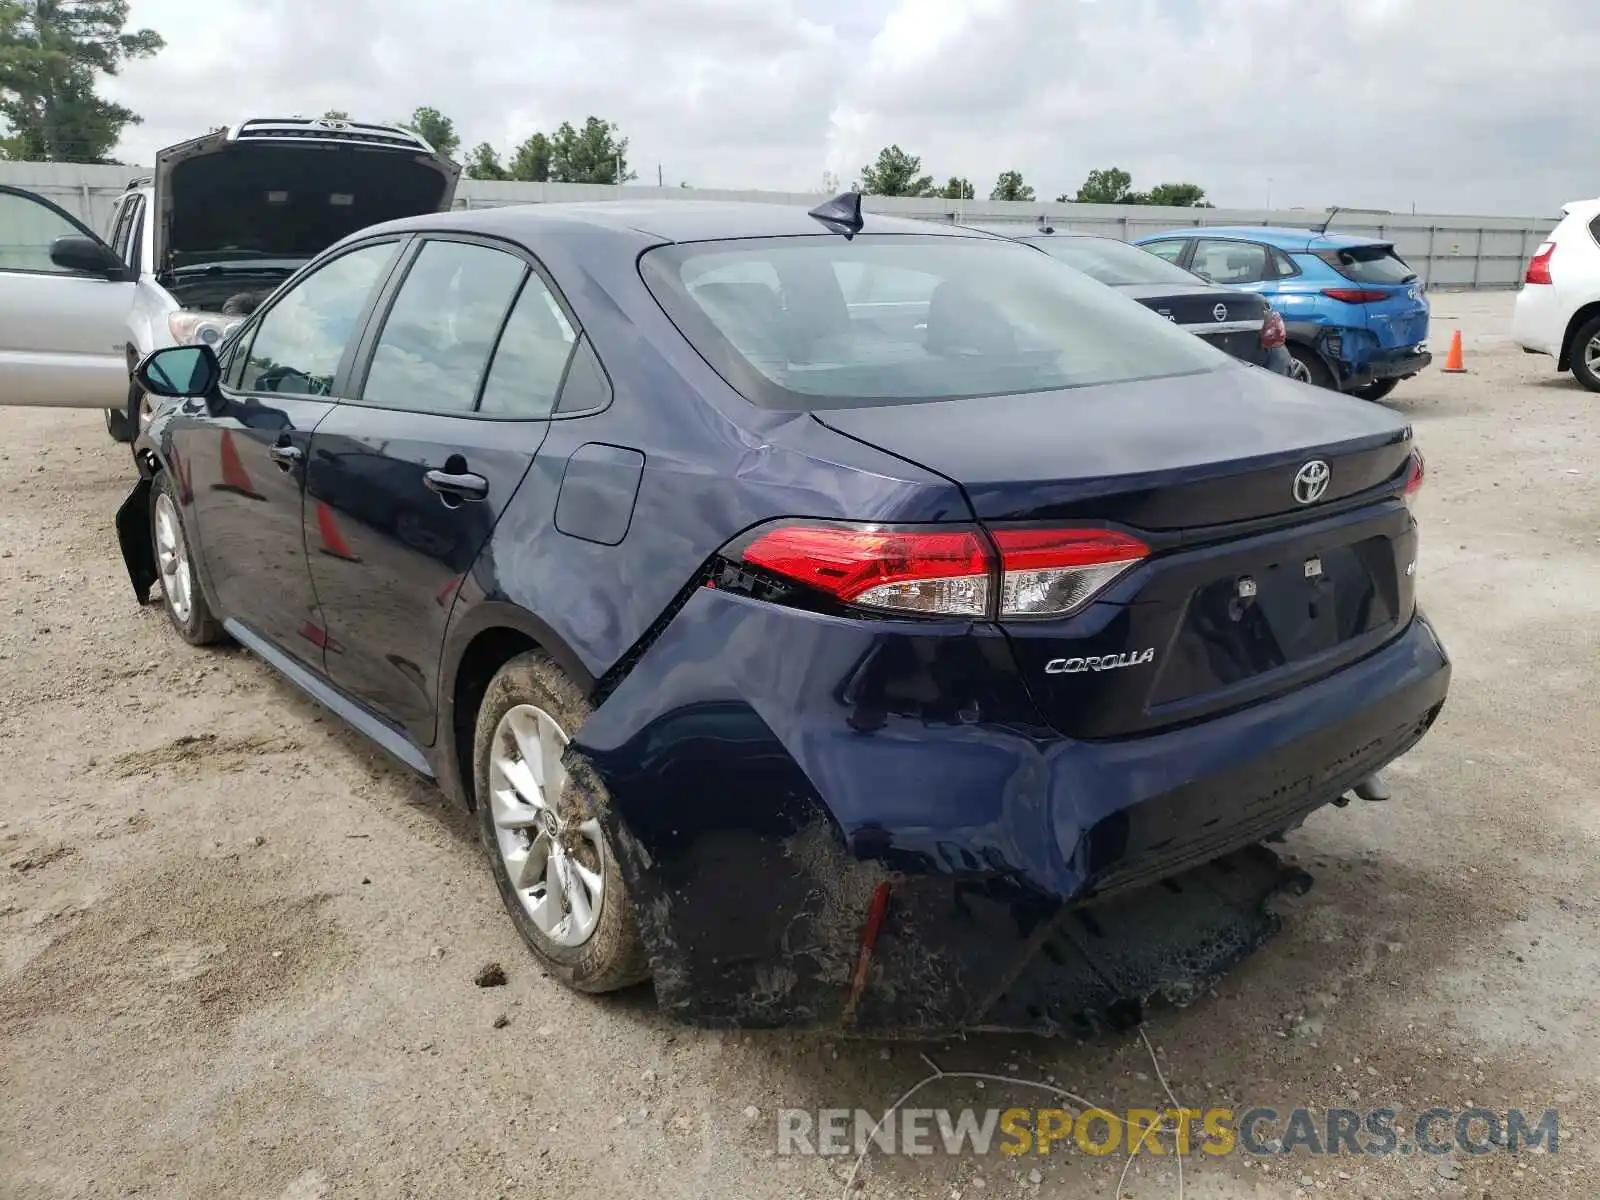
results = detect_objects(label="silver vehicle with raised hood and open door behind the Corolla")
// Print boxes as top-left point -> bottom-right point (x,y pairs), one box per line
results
0,117 -> 461,442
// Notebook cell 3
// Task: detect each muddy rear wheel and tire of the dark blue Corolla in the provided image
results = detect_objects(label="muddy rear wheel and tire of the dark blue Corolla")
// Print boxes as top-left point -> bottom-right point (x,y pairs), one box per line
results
472,651 -> 650,992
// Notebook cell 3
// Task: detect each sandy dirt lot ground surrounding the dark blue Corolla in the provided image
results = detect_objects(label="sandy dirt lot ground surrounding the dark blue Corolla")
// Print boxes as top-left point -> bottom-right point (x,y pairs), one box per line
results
0,294 -> 1600,1200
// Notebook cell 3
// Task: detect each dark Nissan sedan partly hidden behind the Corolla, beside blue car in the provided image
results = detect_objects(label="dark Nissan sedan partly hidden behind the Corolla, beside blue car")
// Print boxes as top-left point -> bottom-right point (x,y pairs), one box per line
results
1018,232 -> 1310,382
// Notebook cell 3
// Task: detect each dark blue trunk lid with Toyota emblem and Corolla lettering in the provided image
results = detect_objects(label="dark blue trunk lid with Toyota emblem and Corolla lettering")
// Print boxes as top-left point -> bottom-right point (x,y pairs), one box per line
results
814,368 -> 1416,738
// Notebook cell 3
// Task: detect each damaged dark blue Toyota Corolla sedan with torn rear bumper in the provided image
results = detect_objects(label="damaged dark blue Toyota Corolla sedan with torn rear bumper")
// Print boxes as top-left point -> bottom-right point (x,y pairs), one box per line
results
117,197 -> 1450,1035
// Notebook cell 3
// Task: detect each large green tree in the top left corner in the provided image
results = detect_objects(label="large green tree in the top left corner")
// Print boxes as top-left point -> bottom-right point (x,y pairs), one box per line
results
0,0 -> 165,163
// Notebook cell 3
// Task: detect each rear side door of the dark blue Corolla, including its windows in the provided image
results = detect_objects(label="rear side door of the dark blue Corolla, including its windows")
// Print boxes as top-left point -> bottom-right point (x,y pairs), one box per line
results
306,237 -> 578,746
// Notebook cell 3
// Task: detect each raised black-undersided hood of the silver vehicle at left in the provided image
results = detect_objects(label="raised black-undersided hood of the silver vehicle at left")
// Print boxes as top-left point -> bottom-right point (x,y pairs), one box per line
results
154,130 -> 461,270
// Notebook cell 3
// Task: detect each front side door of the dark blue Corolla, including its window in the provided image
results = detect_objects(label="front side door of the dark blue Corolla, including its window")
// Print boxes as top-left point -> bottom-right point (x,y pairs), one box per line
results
170,240 -> 400,670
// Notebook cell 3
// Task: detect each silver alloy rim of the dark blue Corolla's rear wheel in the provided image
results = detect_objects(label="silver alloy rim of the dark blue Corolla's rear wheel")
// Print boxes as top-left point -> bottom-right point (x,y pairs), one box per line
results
488,704 -> 605,947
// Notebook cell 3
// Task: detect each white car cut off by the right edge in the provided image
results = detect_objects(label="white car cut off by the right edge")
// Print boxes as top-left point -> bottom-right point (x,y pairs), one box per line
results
1510,198 -> 1600,392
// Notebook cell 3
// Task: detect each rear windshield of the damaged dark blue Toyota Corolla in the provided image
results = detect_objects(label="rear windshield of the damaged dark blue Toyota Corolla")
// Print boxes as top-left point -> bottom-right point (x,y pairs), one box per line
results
640,234 -> 1232,410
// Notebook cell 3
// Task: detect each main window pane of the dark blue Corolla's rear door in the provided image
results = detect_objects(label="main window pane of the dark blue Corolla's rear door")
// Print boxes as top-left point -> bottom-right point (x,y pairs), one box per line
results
362,242 -> 524,413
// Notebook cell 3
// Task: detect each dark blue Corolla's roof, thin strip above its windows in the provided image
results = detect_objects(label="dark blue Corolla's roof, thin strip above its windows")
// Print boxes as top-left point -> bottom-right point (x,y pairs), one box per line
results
363,200 -> 989,242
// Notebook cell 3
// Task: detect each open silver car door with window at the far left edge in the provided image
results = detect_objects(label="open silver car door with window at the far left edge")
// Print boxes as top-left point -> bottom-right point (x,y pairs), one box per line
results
0,187 -> 134,408
